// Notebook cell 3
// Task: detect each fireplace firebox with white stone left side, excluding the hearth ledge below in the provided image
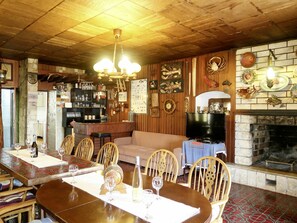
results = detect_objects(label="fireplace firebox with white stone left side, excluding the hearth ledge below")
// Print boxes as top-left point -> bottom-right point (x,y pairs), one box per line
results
235,115 -> 297,174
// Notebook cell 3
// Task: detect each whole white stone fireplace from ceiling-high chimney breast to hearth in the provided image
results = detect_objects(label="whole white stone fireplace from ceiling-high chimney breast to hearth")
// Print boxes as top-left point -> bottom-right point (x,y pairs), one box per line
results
228,39 -> 297,197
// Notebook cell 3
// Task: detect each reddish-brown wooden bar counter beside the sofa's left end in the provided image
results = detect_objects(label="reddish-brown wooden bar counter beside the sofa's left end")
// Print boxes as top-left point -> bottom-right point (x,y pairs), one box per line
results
73,122 -> 135,154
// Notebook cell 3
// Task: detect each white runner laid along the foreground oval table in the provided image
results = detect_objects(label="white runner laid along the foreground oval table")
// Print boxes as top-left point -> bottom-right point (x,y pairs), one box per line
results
63,172 -> 200,223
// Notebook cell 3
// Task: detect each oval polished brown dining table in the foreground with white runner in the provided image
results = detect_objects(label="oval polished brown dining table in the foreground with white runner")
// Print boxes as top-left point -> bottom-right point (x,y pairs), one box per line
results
36,171 -> 212,223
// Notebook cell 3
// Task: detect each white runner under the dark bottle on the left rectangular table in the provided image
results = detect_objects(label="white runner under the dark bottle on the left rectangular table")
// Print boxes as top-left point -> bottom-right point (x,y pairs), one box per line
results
6,149 -> 68,168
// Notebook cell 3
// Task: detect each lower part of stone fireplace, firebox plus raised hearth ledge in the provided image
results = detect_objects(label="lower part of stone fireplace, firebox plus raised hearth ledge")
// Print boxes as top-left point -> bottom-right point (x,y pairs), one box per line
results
228,112 -> 297,197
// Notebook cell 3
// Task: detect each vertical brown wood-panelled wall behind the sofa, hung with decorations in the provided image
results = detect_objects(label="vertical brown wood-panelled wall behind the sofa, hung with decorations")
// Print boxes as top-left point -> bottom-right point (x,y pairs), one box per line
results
110,50 -> 236,162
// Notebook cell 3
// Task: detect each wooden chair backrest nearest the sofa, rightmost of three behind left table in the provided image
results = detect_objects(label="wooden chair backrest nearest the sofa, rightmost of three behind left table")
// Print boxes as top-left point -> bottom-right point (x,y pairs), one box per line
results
96,142 -> 119,169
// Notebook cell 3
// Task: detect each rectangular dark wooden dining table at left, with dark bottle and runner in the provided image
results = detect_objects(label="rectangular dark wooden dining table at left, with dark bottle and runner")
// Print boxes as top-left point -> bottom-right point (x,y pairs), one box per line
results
0,146 -> 103,186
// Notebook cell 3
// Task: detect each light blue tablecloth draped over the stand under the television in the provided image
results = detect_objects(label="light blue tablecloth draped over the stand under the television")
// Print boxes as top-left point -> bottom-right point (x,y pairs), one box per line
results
182,140 -> 227,167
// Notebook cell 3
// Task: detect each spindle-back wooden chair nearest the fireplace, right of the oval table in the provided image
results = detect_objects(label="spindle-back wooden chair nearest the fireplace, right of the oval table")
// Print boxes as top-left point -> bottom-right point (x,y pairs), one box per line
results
187,156 -> 231,222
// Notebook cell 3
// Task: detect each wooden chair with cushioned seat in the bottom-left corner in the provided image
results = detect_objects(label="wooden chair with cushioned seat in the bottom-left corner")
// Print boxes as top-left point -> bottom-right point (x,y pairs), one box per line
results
0,176 -> 36,222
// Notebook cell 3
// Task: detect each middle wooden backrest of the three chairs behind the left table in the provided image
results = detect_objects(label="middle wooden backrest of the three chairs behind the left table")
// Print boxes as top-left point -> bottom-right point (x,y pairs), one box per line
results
74,137 -> 94,161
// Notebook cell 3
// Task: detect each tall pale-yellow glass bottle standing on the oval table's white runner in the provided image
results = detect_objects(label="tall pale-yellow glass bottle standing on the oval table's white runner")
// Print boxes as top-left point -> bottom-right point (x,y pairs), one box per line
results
132,156 -> 143,202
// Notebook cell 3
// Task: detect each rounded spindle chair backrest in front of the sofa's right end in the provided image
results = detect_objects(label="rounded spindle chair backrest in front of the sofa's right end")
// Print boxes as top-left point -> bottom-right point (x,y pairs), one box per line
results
144,149 -> 178,183
